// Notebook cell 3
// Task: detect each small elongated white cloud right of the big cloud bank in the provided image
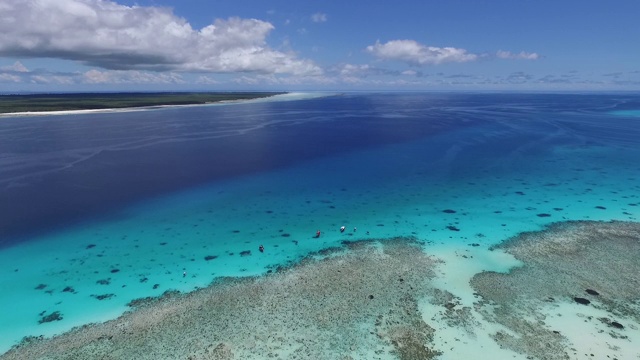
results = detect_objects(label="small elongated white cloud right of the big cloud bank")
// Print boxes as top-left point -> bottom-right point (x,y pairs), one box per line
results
367,40 -> 478,65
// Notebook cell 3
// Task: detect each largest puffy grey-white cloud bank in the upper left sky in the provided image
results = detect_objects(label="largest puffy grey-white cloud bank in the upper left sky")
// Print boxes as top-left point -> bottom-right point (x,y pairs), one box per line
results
0,0 -> 321,75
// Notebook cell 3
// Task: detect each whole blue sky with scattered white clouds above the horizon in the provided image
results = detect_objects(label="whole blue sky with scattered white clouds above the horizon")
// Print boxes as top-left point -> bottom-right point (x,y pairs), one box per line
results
0,0 -> 640,93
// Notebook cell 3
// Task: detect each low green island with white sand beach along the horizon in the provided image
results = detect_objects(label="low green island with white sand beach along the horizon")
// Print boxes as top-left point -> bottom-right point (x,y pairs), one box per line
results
0,92 -> 286,116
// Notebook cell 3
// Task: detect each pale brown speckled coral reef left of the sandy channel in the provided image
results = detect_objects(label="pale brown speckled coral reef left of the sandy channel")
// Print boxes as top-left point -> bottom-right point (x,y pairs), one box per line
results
0,238 -> 439,360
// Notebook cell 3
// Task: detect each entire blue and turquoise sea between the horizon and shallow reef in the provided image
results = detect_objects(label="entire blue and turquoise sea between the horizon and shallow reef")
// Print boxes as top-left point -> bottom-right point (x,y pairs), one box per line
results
0,92 -> 640,358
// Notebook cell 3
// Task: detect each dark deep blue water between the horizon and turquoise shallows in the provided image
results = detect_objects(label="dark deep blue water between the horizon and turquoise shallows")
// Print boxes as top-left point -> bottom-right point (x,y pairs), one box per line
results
0,93 -> 640,245
